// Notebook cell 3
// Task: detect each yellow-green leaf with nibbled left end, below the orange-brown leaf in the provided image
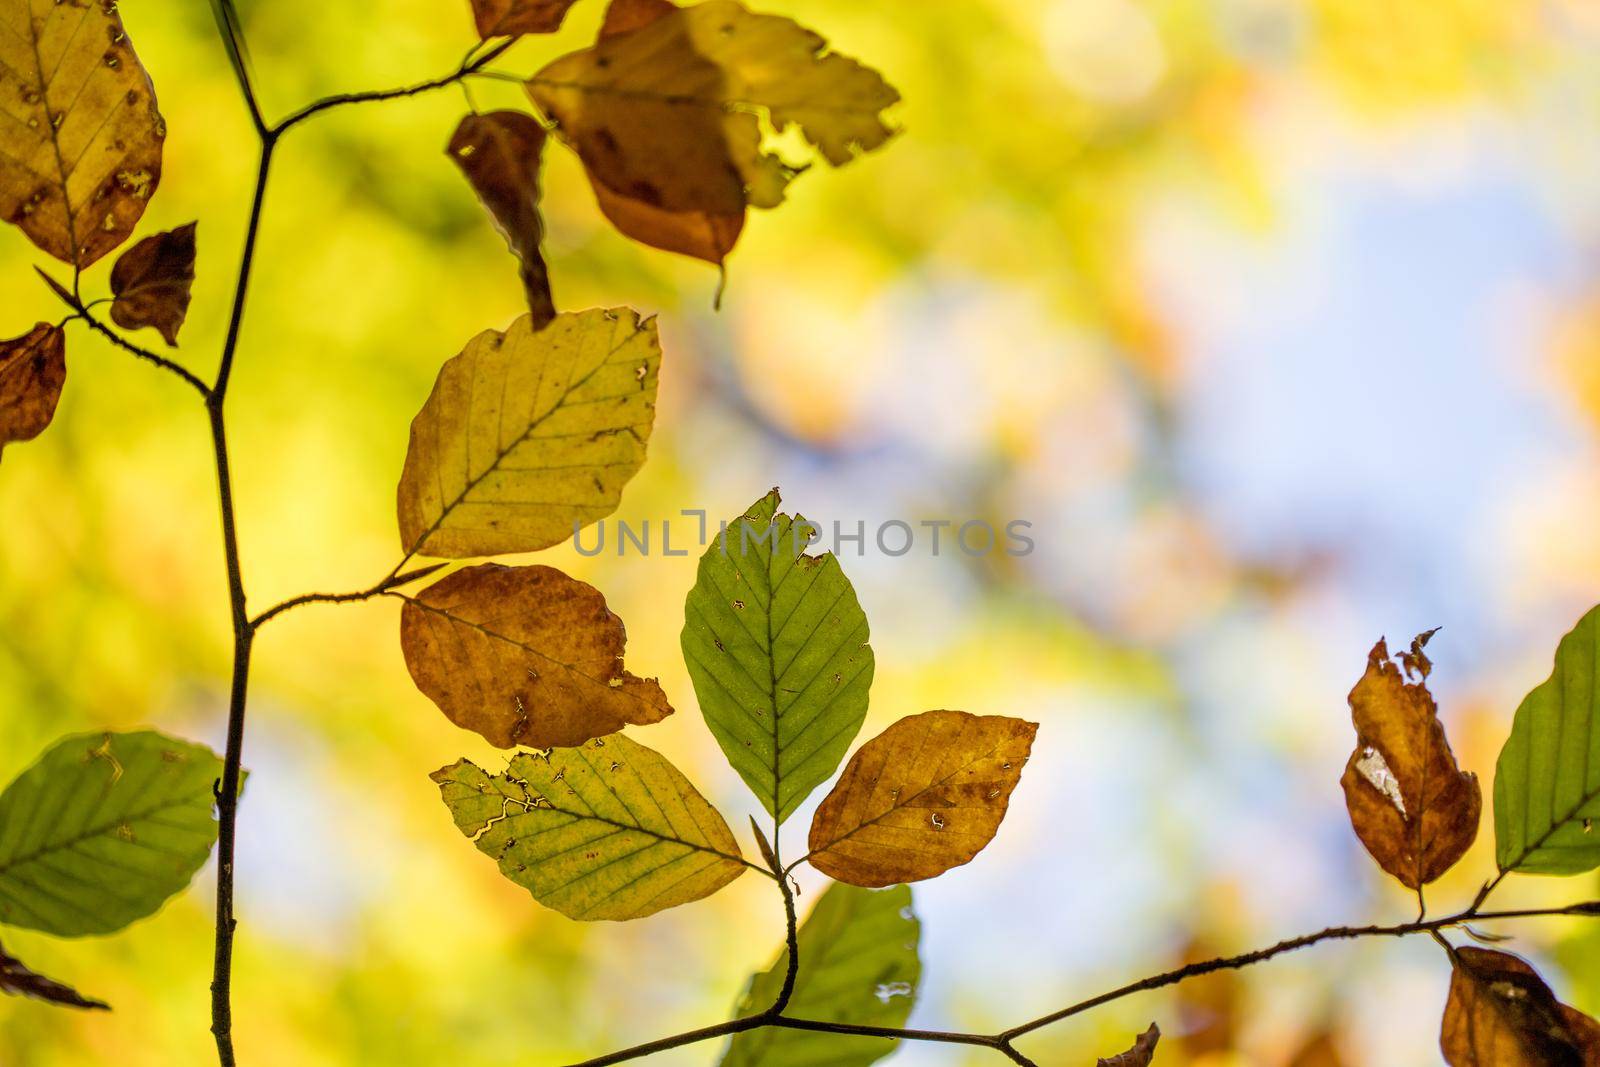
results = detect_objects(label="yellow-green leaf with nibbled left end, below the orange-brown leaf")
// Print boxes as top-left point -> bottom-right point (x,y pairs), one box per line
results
434,734 -> 747,920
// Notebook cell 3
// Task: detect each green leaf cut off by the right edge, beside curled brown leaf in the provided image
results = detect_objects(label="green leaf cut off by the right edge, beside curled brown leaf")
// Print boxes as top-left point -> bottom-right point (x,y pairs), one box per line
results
1494,608 -> 1600,875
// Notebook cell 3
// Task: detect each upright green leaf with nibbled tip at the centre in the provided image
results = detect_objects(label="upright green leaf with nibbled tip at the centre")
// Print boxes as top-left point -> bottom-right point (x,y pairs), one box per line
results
682,490 -> 874,822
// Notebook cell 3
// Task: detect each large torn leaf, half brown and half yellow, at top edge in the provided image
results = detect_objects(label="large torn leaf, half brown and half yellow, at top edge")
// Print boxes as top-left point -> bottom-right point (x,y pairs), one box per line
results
528,0 -> 899,216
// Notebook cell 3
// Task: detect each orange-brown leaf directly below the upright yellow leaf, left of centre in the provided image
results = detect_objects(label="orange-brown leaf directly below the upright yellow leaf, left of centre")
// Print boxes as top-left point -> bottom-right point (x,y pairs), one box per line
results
400,563 -> 672,749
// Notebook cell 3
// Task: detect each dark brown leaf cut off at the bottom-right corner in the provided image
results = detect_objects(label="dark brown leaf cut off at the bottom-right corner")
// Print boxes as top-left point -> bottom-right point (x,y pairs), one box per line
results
1438,945 -> 1600,1067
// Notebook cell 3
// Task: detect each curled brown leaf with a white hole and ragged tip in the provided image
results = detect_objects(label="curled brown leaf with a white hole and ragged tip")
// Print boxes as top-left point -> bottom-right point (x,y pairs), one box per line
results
1341,635 -> 1483,889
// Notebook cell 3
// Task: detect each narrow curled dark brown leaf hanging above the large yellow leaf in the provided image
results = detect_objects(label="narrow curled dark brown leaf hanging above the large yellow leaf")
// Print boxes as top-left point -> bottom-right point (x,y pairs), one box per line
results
446,110 -> 555,328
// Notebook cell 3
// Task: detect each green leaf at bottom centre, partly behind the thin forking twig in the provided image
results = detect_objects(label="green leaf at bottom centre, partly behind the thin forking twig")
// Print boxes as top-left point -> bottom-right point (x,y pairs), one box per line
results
722,881 -> 922,1067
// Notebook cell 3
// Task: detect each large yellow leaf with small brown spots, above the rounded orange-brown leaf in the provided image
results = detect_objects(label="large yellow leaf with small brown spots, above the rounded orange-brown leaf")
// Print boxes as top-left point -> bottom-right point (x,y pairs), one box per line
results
398,309 -> 661,558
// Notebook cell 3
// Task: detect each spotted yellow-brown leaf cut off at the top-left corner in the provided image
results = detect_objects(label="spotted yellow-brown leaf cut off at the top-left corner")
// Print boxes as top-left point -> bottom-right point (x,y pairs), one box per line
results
0,0 -> 166,269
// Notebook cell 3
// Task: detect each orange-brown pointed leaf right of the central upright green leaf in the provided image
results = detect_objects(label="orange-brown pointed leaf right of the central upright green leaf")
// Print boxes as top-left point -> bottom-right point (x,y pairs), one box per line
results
808,712 -> 1038,886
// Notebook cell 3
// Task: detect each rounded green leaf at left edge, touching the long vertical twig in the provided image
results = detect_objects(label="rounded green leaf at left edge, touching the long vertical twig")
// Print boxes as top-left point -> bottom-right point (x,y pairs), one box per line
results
0,731 -> 222,937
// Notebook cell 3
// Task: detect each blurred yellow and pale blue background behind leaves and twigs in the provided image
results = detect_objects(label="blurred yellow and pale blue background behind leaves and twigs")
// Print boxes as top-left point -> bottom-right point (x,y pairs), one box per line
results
0,0 -> 1600,1067
